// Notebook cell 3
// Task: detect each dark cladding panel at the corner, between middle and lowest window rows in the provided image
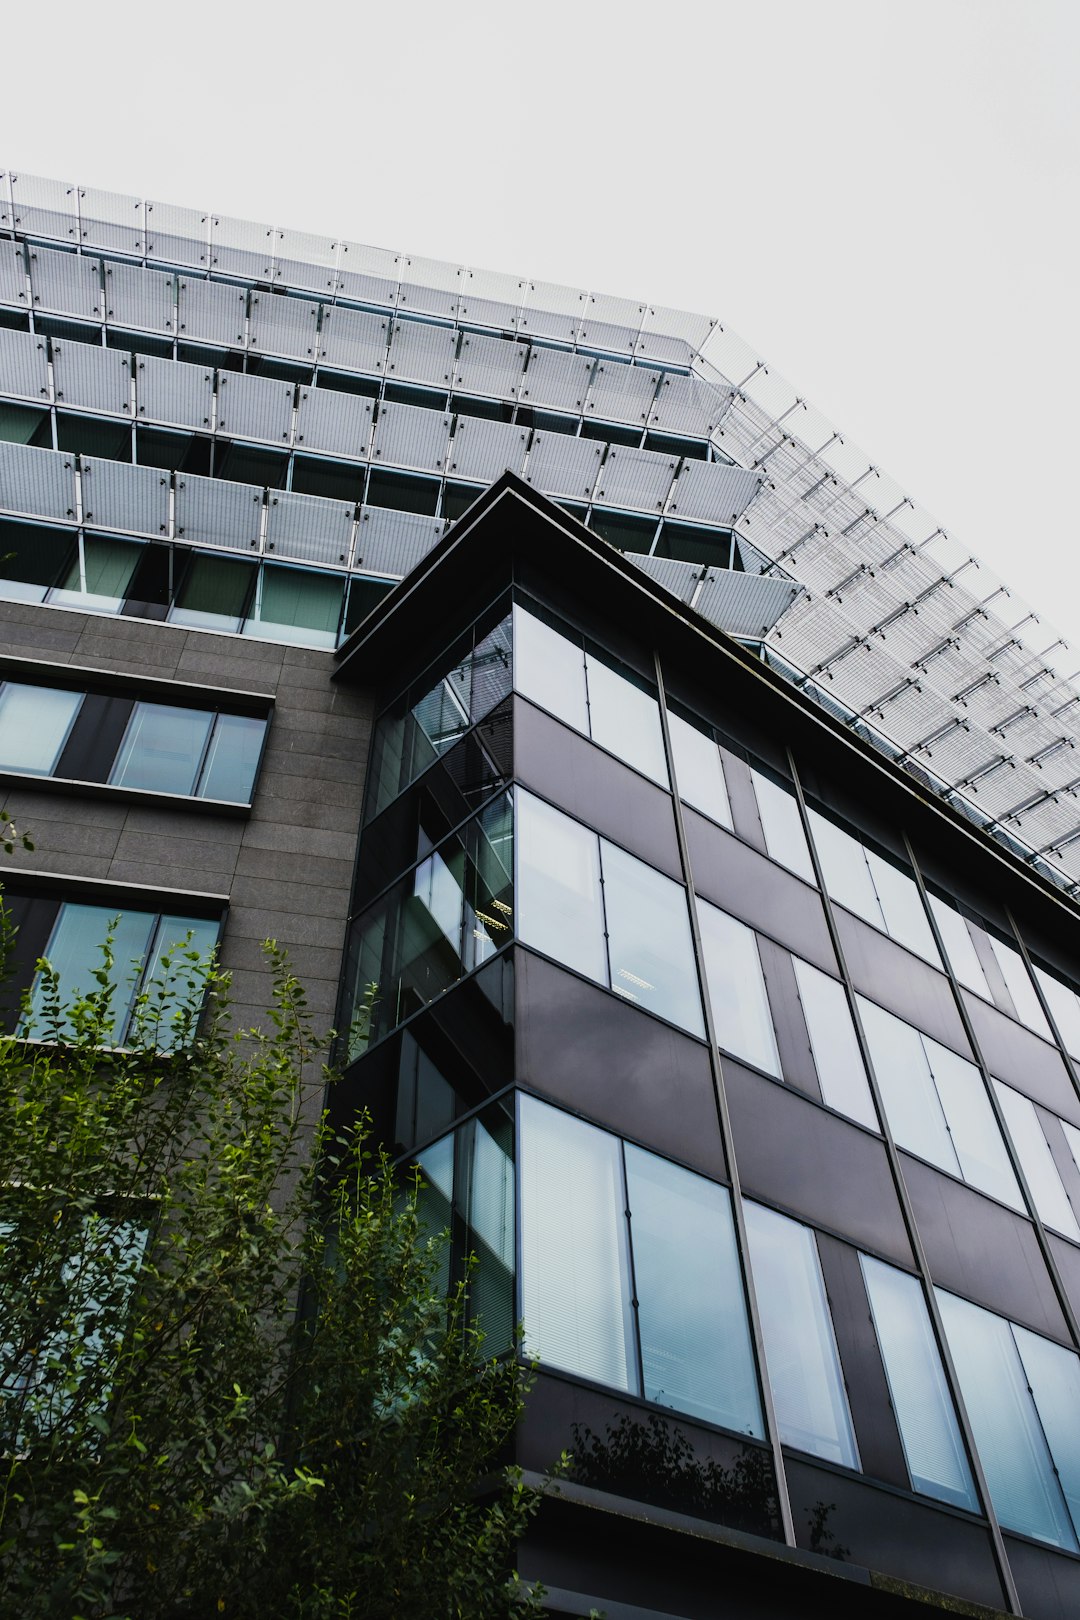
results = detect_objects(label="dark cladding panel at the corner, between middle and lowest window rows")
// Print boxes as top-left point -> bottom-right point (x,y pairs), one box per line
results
515,949 -> 727,1178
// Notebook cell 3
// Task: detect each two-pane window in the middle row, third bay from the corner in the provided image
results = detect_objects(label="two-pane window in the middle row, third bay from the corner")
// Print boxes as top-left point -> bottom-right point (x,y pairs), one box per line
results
858,996 -> 1023,1210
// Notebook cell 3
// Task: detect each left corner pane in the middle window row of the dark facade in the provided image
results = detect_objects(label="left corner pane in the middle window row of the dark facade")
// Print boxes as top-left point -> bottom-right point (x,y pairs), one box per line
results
517,791 -> 607,985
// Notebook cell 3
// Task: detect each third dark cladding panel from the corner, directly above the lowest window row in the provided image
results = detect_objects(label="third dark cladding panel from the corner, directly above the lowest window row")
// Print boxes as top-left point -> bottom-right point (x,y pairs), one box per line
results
900,1153 -> 1069,1345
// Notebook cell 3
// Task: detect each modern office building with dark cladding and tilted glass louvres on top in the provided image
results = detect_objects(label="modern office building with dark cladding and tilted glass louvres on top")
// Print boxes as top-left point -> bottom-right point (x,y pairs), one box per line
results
0,175 -> 1080,1620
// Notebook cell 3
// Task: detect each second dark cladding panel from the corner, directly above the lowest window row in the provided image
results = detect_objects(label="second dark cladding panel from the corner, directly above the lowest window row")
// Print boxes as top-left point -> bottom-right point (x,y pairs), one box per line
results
724,1058 -> 912,1265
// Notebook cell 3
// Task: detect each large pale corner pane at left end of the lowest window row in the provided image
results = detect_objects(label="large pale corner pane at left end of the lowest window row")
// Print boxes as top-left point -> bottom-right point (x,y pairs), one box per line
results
520,1097 -> 640,1395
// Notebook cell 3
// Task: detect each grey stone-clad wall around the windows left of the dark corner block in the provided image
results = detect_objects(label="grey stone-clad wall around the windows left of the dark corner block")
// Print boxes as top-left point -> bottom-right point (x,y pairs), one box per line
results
0,603 -> 371,1027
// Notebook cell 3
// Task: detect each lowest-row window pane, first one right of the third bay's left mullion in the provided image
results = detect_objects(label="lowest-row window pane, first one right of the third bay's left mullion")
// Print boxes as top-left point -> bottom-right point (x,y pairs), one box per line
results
938,1290 -> 1077,1552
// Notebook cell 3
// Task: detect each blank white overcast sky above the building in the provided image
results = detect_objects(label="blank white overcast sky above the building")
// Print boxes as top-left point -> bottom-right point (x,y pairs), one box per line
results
0,0 -> 1080,663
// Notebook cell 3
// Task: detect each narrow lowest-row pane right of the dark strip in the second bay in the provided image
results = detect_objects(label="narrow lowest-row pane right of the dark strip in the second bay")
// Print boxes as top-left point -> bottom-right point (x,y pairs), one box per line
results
858,1254 -> 978,1513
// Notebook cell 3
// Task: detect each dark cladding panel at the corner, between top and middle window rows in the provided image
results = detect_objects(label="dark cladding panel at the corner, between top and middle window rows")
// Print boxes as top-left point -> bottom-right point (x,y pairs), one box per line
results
513,698 -> 682,878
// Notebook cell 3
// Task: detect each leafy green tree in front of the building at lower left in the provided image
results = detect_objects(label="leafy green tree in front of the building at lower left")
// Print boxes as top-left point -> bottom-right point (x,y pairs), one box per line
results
0,920 -> 542,1620
